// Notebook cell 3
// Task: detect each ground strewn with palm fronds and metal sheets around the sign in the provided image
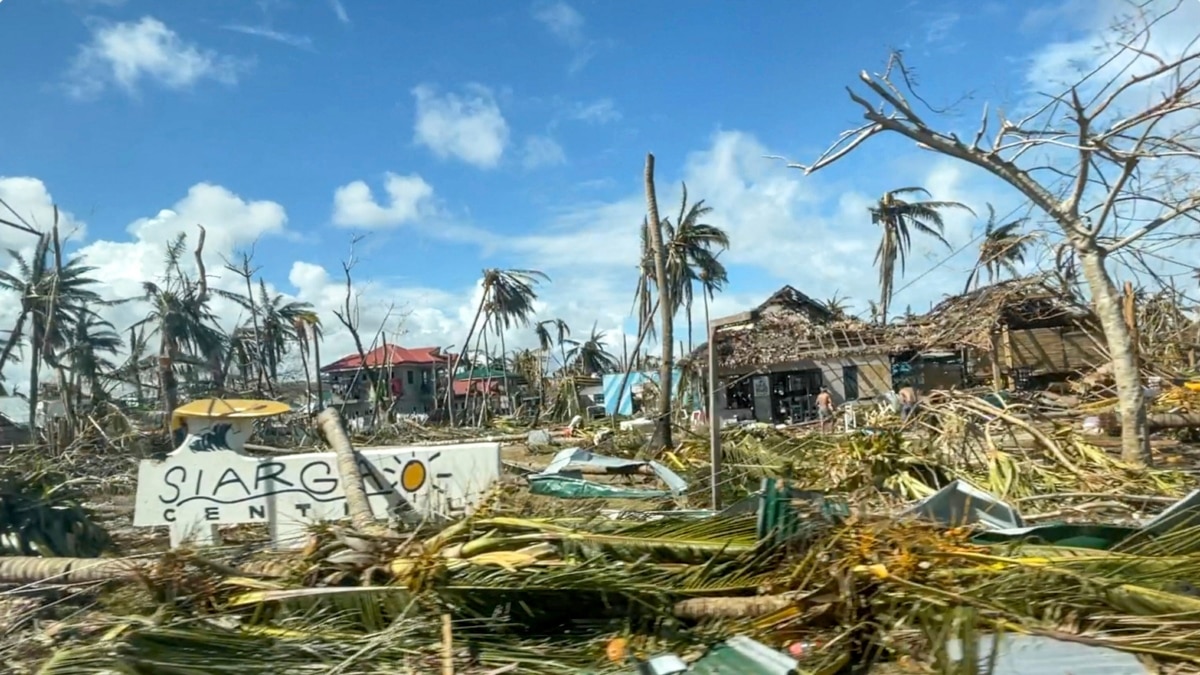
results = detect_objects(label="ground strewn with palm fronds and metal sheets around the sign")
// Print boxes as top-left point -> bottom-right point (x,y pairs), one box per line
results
0,389 -> 1200,675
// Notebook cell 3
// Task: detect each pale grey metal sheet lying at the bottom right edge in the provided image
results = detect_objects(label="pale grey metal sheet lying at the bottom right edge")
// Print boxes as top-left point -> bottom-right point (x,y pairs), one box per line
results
946,634 -> 1151,675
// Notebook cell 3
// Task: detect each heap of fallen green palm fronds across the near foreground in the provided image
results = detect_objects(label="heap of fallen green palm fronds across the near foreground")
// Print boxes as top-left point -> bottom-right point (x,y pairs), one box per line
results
16,487 -> 1200,675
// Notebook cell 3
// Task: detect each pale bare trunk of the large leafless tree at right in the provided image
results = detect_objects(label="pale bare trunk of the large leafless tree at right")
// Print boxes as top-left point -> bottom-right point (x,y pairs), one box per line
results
1079,253 -> 1151,465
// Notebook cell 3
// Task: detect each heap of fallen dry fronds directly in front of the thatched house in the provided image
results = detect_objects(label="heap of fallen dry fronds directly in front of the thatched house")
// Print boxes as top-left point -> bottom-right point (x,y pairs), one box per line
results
681,393 -> 1196,509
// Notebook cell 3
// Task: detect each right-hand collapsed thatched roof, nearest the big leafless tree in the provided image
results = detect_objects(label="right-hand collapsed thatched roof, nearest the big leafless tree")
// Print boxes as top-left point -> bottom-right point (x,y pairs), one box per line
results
894,277 -> 1094,351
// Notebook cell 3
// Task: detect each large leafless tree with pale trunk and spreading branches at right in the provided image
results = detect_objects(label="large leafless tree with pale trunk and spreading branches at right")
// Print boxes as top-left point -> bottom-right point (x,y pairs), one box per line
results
790,0 -> 1200,464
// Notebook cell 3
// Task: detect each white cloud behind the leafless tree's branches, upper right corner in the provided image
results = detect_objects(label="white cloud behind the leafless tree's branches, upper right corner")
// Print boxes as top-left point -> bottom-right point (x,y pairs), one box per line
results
1014,0 -> 1200,276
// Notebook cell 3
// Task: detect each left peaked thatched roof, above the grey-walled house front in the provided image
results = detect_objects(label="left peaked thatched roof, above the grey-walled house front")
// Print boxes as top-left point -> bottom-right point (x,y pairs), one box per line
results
689,286 -> 888,370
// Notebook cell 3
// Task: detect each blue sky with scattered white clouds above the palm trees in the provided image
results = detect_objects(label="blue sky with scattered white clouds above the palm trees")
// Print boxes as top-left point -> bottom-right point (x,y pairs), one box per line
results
0,0 -> 1200,384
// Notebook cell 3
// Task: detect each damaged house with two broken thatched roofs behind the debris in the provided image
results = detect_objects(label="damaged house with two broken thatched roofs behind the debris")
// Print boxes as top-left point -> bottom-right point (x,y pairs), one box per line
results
689,279 -> 1106,424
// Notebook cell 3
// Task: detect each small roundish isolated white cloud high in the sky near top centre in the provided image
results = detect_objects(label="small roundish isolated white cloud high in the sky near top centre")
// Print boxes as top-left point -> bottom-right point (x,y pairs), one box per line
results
413,84 -> 509,168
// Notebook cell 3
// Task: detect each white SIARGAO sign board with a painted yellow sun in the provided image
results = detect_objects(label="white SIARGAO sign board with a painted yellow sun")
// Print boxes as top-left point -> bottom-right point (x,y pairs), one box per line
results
133,439 -> 500,548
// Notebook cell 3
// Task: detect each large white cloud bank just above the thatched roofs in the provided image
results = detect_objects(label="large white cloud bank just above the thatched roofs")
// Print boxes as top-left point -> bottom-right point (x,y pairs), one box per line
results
498,131 -> 1014,324
